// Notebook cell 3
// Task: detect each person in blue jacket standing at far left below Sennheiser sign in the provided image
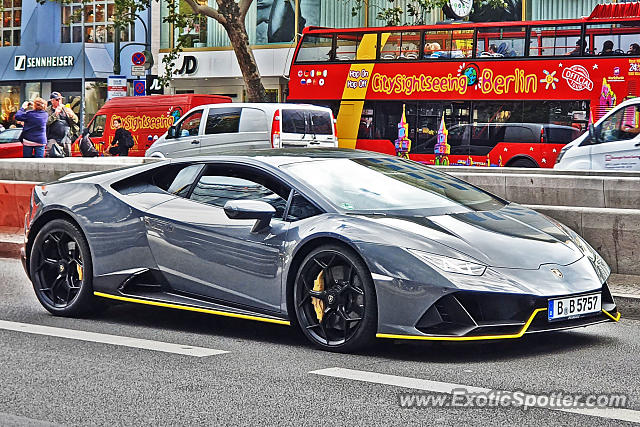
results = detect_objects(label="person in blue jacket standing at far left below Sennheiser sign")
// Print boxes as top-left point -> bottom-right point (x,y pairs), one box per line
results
15,98 -> 49,157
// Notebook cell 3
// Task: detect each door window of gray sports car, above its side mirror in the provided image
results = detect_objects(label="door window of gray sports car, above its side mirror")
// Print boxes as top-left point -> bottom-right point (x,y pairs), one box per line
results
189,165 -> 291,219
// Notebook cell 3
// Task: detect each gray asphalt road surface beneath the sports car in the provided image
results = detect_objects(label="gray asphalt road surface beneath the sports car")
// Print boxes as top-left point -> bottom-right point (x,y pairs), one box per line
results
0,259 -> 640,426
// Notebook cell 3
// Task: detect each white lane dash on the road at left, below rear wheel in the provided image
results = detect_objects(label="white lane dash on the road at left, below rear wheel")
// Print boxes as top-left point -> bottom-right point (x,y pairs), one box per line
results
0,320 -> 227,357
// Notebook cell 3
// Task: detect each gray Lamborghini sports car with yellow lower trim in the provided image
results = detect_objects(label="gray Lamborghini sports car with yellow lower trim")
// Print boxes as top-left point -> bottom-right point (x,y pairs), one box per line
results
23,149 -> 620,351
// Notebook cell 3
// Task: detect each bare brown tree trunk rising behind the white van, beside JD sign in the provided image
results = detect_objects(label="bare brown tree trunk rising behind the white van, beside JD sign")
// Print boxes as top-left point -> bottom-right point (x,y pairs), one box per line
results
224,17 -> 267,102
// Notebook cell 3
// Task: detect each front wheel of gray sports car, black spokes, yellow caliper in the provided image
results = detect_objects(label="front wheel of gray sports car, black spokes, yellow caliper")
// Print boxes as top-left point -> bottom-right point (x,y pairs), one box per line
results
293,245 -> 378,352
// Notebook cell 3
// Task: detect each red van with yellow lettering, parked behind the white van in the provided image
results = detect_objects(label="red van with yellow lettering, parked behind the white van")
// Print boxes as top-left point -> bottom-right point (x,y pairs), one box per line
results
72,94 -> 231,157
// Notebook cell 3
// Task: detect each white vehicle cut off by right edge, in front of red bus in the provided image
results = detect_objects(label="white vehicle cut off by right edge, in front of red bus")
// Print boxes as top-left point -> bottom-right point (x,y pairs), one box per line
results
553,98 -> 640,171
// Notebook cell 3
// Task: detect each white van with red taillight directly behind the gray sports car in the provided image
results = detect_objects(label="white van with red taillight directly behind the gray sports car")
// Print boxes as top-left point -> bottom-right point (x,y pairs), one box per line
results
145,103 -> 338,157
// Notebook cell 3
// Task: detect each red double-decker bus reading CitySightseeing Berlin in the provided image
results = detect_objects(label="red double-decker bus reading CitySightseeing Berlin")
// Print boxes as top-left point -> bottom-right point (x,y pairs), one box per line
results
288,3 -> 640,167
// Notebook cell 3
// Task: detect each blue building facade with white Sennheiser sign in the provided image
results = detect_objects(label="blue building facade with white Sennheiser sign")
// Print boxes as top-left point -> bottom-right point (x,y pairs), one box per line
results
0,0 -> 149,126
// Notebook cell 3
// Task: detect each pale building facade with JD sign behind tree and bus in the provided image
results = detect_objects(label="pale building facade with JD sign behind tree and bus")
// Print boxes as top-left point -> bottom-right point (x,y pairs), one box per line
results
153,0 -> 616,101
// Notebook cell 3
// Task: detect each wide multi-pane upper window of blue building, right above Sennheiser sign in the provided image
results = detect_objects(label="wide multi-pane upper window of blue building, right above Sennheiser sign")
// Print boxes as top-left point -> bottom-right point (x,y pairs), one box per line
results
61,0 -> 135,43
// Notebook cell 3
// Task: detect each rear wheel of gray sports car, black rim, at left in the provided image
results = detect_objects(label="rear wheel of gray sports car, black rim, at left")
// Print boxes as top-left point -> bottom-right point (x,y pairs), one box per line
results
29,219 -> 97,316
